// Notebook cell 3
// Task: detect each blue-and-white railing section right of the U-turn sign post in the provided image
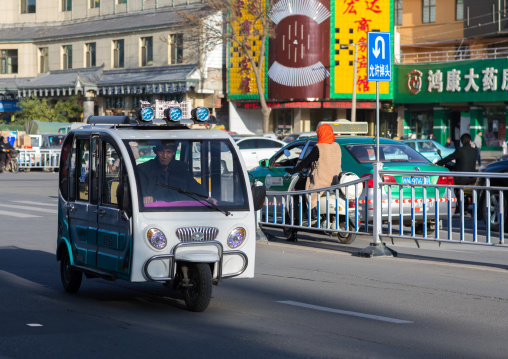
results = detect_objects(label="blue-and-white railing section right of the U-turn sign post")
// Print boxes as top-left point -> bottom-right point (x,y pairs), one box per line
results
373,170 -> 508,246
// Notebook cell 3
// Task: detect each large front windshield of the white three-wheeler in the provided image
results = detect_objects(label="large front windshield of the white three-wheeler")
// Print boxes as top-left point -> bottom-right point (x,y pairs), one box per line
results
125,139 -> 249,212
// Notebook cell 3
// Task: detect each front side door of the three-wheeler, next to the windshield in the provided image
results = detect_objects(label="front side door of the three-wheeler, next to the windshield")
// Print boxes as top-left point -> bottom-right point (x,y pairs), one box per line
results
97,137 -> 132,279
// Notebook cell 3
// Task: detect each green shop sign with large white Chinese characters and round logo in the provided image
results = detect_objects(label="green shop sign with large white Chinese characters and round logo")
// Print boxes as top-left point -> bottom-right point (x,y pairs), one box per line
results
394,59 -> 508,104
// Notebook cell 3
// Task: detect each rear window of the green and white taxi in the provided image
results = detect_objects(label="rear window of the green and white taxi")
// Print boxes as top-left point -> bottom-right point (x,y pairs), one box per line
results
342,143 -> 429,163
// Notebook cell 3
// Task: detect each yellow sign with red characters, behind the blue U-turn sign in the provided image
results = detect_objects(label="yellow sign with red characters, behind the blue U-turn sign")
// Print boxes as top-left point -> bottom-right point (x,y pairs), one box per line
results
332,0 -> 391,98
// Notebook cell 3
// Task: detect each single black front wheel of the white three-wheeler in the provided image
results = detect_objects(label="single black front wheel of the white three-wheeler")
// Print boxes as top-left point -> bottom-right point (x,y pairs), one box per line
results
183,263 -> 212,312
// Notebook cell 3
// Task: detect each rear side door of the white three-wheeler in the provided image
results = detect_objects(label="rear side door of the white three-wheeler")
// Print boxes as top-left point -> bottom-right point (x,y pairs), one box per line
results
65,135 -> 98,266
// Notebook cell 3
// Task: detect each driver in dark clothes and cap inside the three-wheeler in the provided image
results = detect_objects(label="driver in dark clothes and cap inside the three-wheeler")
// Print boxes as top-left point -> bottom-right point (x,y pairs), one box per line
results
138,140 -> 208,205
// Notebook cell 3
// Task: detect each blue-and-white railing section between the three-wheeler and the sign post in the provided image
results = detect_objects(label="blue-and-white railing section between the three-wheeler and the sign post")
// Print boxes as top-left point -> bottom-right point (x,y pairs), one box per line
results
259,176 -> 372,239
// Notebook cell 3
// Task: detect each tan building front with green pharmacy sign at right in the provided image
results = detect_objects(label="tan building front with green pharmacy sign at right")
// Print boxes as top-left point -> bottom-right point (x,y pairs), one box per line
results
394,0 -> 508,151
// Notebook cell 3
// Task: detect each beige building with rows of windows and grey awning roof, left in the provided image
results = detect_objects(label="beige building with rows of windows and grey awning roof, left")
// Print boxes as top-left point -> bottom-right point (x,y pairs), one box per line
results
0,0 -> 225,122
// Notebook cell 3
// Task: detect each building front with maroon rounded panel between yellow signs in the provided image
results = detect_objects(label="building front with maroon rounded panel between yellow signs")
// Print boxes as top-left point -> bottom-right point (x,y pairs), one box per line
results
228,0 -> 397,137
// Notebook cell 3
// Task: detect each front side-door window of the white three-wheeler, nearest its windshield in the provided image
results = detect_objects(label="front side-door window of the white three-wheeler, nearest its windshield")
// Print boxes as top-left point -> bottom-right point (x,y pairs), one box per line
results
101,141 -> 123,206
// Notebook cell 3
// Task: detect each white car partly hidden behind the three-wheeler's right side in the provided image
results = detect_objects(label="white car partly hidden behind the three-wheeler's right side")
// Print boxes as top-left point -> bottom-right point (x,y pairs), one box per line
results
234,137 -> 287,171
